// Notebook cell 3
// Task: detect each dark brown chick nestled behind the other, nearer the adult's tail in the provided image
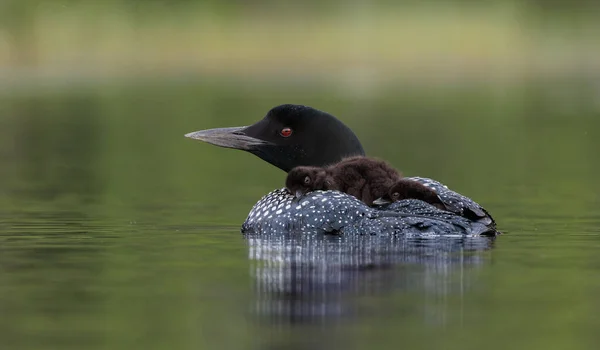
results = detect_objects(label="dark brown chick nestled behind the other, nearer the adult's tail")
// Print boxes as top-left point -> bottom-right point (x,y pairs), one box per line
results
373,179 -> 448,210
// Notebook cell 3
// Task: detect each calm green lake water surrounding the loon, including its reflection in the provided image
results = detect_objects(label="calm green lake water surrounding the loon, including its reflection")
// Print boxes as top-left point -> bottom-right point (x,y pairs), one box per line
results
0,82 -> 600,349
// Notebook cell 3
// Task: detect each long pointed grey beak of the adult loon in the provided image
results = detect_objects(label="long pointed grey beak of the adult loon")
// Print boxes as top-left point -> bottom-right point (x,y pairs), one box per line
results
185,126 -> 269,151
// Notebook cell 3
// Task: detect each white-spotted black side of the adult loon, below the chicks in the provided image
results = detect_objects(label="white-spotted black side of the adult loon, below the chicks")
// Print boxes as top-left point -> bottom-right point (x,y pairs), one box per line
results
242,189 -> 494,235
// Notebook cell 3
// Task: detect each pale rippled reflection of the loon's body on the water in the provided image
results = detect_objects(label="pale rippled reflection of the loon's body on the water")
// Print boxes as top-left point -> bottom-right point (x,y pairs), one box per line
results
246,233 -> 495,324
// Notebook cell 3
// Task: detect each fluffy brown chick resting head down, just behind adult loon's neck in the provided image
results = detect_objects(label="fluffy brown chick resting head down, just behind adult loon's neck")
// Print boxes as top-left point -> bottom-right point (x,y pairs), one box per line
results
285,156 -> 404,205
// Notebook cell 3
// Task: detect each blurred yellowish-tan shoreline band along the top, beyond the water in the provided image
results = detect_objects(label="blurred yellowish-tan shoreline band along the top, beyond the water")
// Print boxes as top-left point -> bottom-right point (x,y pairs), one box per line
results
0,3 -> 600,91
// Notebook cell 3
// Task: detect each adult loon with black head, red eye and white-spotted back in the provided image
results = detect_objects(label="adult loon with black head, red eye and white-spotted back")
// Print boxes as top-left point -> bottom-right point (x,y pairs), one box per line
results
185,104 -> 498,235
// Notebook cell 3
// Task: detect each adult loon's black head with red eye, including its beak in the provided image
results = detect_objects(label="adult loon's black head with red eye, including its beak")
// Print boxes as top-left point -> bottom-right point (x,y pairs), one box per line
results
185,104 -> 365,172
